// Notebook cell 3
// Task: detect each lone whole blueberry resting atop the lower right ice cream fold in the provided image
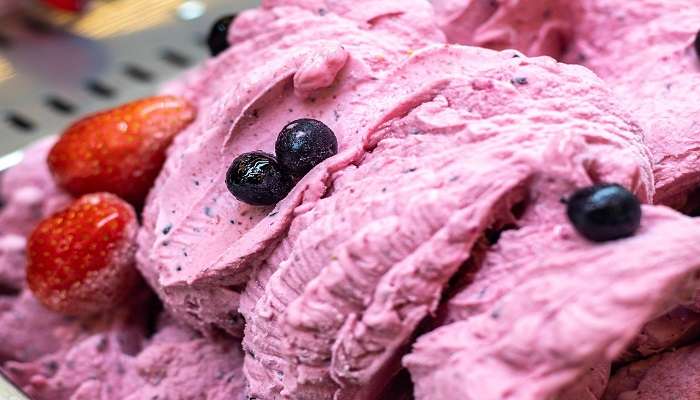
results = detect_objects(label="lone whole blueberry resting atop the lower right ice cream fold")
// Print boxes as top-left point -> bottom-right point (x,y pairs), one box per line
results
566,184 -> 642,242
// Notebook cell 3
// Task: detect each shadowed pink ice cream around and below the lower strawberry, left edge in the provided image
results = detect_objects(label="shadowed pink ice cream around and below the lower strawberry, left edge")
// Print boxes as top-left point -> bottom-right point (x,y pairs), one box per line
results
0,139 -> 245,400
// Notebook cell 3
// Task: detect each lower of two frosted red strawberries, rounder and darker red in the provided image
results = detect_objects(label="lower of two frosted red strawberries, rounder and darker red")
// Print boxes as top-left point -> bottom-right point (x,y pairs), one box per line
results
27,193 -> 139,315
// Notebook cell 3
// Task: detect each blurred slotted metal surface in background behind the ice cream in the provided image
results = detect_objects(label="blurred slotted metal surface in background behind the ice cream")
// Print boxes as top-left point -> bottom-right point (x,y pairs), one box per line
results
0,0 -> 259,166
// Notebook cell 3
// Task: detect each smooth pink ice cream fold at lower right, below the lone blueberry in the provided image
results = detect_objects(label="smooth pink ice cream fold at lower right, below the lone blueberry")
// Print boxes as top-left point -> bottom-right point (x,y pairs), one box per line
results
405,206 -> 700,400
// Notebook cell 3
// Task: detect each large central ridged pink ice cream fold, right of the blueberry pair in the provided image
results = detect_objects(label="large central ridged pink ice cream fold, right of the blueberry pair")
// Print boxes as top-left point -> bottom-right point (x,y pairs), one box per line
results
243,47 -> 651,399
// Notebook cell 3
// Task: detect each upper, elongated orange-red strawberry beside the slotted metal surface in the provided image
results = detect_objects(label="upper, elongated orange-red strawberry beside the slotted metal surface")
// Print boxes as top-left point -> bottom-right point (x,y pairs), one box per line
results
48,96 -> 195,207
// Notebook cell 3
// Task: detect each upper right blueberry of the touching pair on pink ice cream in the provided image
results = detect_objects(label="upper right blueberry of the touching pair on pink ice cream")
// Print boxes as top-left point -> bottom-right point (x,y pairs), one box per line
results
275,119 -> 338,178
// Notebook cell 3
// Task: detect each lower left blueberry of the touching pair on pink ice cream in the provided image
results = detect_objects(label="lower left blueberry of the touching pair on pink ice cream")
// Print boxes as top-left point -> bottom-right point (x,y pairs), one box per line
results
226,151 -> 293,206
